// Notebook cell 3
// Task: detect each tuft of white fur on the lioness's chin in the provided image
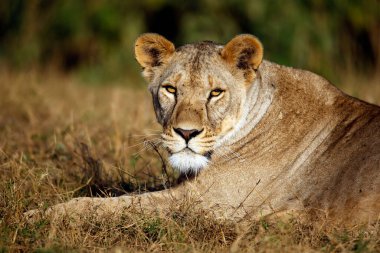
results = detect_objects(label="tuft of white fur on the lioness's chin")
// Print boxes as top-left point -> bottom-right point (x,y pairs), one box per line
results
169,151 -> 209,173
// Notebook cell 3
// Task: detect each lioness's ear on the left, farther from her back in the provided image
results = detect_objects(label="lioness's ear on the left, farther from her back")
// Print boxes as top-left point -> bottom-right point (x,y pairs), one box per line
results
135,33 -> 175,81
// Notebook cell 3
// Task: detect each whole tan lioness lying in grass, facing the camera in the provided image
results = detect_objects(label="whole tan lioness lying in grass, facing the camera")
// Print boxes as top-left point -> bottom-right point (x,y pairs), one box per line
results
27,33 -> 380,223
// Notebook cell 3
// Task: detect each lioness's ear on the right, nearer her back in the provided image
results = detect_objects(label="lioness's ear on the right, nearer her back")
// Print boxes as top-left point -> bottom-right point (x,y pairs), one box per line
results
222,34 -> 264,82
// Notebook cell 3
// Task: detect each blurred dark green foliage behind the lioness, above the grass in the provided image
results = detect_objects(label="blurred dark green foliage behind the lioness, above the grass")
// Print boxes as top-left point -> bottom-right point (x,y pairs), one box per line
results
0,0 -> 380,84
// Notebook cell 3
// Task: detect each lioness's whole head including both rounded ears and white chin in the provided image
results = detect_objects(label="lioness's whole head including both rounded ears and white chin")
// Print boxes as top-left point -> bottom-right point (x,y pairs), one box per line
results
136,34 -> 262,172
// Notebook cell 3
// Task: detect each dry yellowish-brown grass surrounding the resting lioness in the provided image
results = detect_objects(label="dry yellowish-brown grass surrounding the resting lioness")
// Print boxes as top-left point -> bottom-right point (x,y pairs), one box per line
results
0,68 -> 380,252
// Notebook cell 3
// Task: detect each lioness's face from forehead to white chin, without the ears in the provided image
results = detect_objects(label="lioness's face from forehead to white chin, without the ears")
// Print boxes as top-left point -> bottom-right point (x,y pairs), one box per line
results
151,48 -> 246,170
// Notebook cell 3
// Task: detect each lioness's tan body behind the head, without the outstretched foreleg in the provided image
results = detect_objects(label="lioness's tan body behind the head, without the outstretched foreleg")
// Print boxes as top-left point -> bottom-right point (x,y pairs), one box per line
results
178,62 -> 380,221
